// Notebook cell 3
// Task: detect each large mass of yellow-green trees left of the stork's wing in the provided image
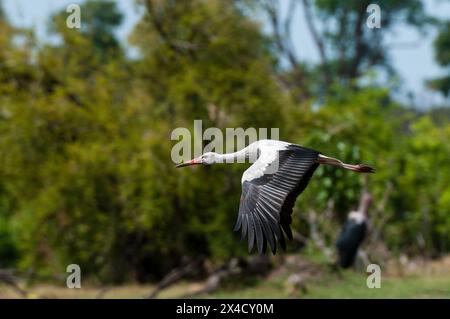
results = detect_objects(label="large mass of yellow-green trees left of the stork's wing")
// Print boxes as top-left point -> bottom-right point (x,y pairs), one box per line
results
2,1 -> 283,282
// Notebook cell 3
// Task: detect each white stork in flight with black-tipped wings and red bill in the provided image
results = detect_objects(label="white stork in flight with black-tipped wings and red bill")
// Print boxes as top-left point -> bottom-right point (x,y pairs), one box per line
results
176,140 -> 375,254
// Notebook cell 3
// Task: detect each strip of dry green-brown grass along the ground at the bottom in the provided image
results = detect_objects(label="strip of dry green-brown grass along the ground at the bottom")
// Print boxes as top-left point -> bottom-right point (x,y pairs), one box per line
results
0,256 -> 450,299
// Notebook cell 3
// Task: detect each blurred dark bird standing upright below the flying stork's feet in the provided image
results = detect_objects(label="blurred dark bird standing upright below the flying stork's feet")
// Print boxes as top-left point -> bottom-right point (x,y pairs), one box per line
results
336,193 -> 372,268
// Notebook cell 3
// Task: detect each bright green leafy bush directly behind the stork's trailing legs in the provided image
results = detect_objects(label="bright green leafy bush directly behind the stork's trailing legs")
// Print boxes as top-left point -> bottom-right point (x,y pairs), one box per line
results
299,89 -> 402,218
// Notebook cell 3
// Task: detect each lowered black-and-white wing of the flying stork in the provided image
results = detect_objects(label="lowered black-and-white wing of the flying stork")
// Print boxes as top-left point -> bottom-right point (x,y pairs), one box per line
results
234,144 -> 319,254
